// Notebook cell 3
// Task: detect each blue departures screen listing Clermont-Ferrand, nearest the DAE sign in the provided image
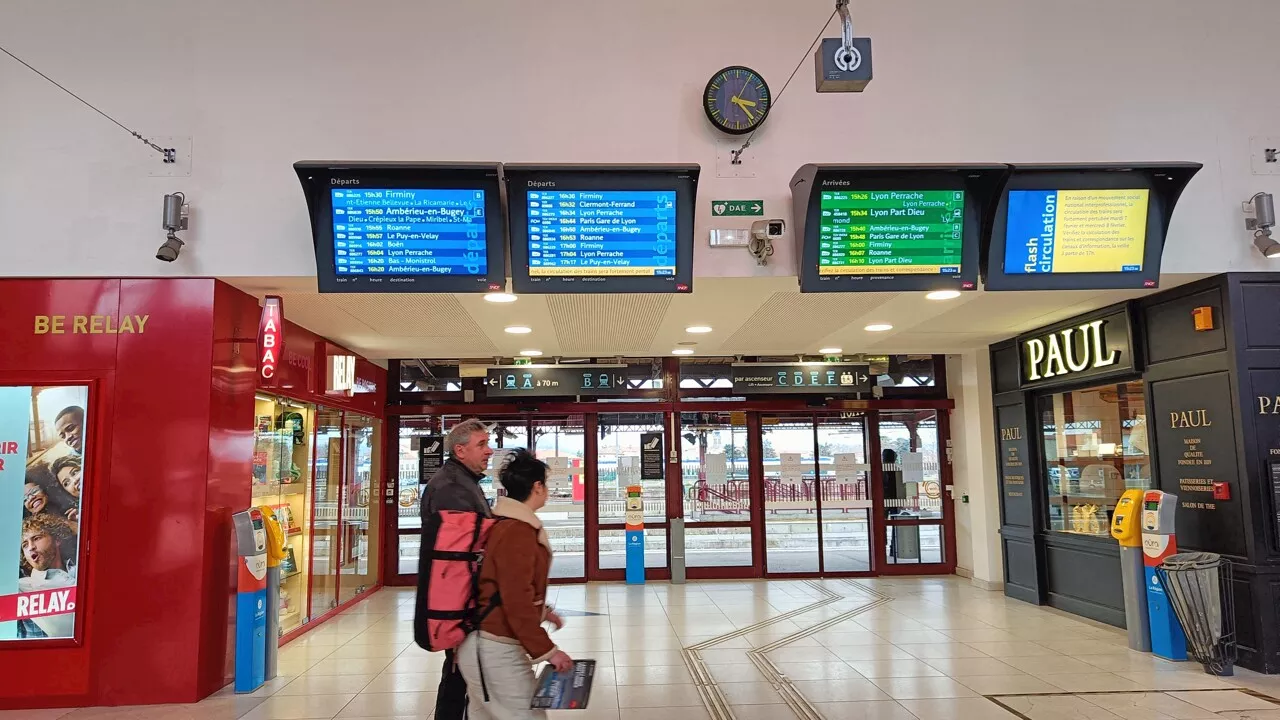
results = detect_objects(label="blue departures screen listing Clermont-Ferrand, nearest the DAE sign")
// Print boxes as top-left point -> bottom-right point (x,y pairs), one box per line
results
527,190 -> 676,277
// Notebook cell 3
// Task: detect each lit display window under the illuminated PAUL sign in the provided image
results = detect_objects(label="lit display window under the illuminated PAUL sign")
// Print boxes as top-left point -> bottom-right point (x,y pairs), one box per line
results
1038,380 -> 1152,538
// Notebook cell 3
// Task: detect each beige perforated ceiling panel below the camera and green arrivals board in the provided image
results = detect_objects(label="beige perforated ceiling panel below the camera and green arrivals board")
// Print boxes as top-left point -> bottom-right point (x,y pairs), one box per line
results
719,292 -> 897,355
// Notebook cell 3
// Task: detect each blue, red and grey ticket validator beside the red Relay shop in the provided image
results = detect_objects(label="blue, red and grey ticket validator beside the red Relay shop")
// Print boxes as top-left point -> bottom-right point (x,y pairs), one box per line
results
232,507 -> 266,693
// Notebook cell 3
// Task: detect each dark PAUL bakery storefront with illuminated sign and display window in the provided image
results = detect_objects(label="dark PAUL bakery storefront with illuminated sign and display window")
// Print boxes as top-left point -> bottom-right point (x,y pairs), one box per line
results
991,275 -> 1280,673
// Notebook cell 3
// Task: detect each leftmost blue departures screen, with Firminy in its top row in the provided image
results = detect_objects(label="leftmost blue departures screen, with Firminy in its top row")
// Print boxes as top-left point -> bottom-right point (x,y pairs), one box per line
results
333,188 -> 489,275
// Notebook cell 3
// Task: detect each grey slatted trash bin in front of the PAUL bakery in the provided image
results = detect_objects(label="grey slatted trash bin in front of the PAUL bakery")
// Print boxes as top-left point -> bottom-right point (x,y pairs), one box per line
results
1157,552 -> 1236,676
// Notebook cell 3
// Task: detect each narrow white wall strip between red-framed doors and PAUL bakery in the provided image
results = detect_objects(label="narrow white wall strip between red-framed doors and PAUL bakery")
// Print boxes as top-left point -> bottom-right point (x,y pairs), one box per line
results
947,350 -> 1005,588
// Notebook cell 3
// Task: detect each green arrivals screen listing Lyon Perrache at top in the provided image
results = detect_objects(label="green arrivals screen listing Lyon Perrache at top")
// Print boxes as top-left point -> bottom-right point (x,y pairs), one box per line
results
818,190 -> 964,275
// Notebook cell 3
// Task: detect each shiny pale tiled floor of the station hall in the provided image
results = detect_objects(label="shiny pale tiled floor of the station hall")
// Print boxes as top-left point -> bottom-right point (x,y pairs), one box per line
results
10,578 -> 1280,720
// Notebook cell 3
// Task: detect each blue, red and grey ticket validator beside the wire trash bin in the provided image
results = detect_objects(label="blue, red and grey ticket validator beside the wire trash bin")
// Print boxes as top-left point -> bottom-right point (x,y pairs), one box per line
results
1142,489 -> 1187,660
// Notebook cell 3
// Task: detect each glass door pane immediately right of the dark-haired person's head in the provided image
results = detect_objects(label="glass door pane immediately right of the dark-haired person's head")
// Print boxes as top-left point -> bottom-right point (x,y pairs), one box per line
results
529,414 -> 594,580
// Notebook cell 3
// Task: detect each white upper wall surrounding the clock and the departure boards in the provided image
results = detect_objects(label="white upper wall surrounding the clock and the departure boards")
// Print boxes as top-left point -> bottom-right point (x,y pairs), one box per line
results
0,0 -> 1280,275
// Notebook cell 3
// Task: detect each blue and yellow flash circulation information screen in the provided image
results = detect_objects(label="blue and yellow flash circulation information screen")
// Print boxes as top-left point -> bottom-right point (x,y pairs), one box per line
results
1005,190 -> 1151,274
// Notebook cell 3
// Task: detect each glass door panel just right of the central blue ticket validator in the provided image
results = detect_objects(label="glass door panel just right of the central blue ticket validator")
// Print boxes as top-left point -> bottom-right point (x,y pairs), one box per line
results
680,413 -> 756,577
